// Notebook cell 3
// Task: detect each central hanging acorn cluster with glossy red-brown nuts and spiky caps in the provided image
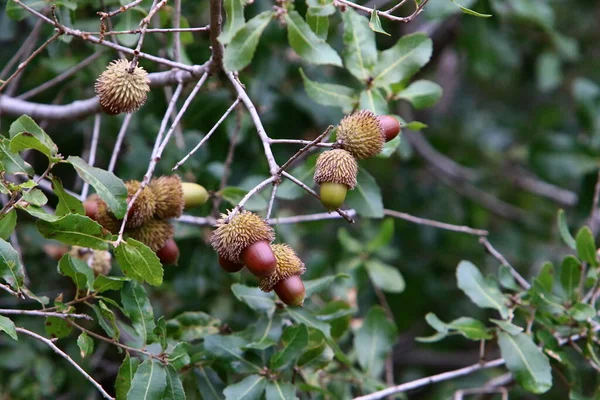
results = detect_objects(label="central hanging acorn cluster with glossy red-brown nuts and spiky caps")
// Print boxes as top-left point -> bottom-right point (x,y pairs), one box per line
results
211,210 -> 306,306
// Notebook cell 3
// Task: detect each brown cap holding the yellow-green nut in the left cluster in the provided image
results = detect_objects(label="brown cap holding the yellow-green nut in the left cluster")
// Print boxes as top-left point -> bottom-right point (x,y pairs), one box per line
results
149,175 -> 184,219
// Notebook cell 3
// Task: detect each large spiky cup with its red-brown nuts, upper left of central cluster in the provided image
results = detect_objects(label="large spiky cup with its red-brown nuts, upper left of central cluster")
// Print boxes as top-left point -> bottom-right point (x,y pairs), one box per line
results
211,210 -> 277,277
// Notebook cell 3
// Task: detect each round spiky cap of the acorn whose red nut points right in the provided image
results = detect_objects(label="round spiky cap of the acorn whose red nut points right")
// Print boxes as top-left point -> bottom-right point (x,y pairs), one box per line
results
336,110 -> 385,160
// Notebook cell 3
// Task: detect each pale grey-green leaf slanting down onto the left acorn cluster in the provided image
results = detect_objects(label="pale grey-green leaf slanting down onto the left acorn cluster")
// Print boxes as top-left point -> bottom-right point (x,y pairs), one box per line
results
67,156 -> 127,219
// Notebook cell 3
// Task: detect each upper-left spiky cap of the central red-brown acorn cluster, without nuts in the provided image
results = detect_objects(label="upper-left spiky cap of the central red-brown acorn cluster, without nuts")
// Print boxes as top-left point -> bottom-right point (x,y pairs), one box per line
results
210,210 -> 275,264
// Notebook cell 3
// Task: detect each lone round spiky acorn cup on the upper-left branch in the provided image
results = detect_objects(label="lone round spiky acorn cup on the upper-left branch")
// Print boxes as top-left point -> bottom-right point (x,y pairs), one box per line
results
94,59 -> 150,115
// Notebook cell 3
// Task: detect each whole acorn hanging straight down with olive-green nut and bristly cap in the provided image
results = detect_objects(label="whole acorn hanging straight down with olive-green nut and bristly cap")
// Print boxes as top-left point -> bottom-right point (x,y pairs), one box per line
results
314,149 -> 358,211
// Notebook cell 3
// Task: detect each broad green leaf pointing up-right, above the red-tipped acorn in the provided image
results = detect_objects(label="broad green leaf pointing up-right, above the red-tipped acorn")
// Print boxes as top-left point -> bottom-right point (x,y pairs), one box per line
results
373,33 -> 433,87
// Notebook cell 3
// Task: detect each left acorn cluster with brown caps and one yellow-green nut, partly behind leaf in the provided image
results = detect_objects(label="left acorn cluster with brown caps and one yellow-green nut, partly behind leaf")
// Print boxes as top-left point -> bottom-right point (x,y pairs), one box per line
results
83,175 -> 208,264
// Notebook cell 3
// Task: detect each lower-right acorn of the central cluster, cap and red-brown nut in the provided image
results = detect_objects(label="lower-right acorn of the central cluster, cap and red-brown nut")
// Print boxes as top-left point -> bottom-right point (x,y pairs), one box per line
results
259,244 -> 306,306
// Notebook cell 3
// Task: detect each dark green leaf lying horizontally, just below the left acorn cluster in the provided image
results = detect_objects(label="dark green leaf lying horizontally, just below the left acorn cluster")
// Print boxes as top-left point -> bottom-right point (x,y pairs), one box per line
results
35,214 -> 111,250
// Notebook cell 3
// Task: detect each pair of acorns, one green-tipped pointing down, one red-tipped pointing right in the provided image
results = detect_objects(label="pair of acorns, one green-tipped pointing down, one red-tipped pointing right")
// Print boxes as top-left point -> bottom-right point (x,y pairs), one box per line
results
314,110 -> 400,211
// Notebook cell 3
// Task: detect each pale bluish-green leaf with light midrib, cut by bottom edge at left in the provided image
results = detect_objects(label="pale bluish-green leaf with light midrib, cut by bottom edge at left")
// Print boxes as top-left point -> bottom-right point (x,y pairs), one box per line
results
127,359 -> 167,400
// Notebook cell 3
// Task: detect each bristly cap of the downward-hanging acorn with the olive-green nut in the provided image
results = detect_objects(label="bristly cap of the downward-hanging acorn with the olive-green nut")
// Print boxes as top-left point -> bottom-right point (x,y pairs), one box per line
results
314,149 -> 358,190
